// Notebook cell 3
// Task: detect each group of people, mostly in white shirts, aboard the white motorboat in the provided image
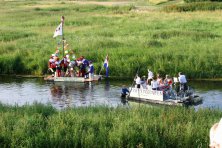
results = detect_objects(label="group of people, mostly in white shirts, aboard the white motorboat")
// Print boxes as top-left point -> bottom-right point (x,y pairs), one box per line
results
134,69 -> 188,91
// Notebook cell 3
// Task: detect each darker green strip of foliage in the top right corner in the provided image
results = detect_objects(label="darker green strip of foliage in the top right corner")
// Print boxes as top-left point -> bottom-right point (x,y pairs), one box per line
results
163,0 -> 222,12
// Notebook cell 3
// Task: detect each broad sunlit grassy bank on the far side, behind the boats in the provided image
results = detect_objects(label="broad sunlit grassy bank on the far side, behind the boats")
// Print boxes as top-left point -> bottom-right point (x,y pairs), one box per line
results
0,1 -> 222,78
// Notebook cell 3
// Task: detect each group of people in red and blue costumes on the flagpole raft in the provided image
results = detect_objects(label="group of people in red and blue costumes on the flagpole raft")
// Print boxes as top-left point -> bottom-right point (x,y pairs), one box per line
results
48,50 -> 94,79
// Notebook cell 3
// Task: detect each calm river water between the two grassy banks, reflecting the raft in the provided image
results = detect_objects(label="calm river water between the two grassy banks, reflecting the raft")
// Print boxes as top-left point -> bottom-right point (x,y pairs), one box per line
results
0,76 -> 222,109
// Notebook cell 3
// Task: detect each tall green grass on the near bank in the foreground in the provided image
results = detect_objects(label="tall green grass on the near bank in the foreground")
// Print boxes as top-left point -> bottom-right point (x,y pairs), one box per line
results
0,104 -> 222,148
